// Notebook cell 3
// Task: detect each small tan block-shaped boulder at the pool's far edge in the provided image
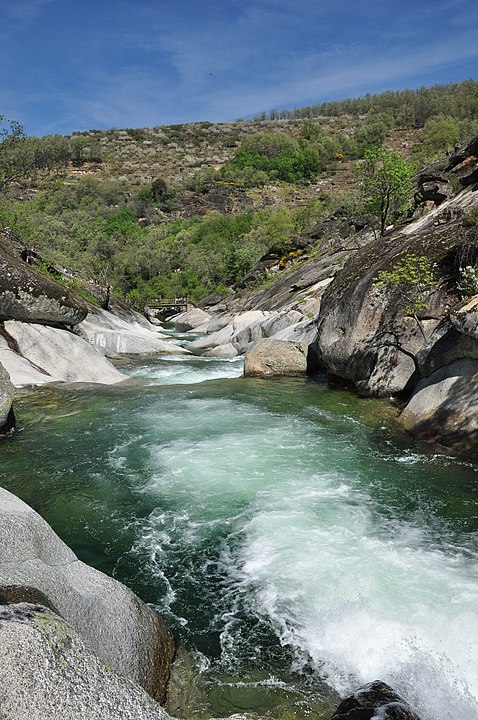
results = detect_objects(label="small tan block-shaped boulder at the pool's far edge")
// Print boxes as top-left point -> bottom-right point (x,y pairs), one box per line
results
244,338 -> 309,377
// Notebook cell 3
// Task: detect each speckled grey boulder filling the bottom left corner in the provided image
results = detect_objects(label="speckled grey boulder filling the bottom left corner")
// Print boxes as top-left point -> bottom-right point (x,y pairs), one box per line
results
0,602 -> 176,720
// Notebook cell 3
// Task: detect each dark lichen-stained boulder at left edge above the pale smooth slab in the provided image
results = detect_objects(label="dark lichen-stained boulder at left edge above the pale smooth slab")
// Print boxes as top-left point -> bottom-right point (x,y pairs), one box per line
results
0,247 -> 87,325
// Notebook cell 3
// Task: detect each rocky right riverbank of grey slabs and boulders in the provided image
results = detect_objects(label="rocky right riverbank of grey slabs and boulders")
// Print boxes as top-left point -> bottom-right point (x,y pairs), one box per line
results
162,133 -> 478,452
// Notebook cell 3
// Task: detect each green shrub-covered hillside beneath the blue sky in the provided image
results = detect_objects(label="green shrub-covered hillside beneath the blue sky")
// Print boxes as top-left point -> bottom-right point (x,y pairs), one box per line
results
0,81 -> 478,307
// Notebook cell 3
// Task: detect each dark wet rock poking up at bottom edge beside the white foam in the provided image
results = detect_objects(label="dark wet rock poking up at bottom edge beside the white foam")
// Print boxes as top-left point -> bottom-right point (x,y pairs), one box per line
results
331,680 -> 420,720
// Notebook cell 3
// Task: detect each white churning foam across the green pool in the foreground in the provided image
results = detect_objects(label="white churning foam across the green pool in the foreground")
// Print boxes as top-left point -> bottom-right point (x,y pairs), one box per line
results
116,372 -> 478,720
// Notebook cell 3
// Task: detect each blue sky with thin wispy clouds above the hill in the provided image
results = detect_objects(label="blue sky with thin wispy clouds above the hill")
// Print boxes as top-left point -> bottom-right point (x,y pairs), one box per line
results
0,0 -> 478,135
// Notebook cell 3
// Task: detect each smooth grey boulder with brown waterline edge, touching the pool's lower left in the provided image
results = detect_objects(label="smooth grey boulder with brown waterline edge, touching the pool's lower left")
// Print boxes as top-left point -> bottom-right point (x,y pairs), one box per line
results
0,488 -> 174,700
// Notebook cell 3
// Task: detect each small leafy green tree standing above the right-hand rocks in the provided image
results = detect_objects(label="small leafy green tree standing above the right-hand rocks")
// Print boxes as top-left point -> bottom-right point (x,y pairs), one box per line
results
357,146 -> 414,235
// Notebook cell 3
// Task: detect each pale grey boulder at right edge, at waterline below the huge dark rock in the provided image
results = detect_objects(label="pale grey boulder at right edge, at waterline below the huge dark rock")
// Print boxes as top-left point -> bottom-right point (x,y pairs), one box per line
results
399,358 -> 478,451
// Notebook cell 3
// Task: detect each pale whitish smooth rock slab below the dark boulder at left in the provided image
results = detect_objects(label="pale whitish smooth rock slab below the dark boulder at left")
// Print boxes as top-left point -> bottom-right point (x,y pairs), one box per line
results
5,320 -> 126,385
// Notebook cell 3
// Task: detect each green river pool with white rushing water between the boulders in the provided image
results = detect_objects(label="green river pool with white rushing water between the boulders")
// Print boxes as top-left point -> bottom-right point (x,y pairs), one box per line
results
0,344 -> 478,720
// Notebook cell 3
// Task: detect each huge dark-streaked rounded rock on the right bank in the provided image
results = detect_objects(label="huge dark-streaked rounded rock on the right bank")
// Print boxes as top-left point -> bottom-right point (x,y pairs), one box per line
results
318,186 -> 478,396
